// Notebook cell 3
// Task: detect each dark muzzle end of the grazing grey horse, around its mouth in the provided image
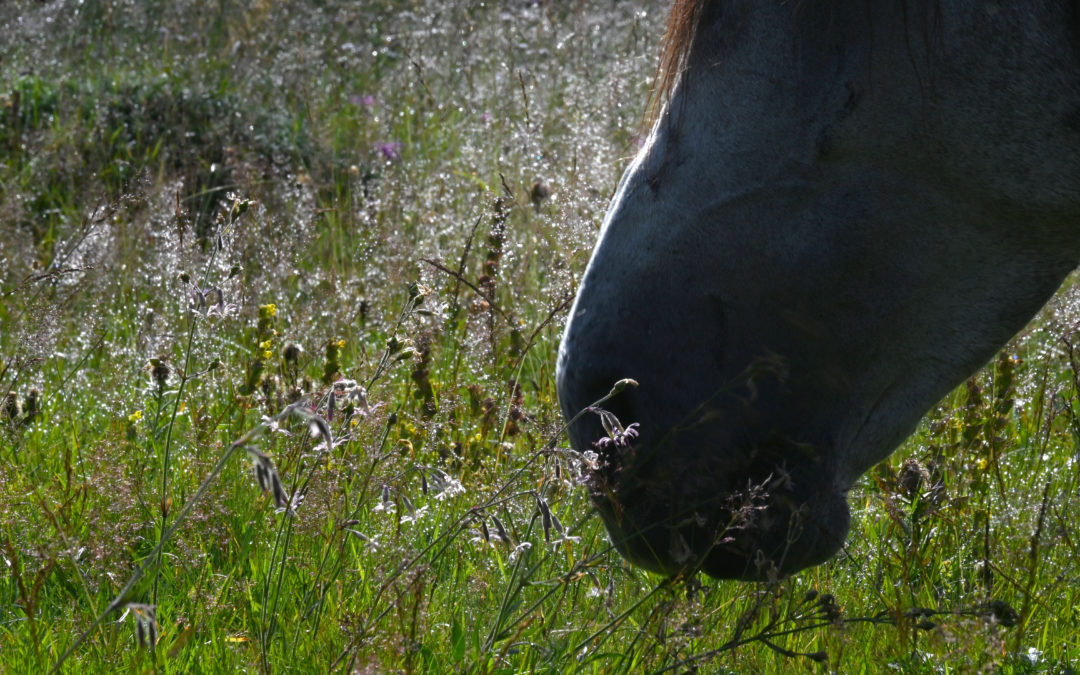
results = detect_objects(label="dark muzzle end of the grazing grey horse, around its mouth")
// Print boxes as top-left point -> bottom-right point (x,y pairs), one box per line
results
586,432 -> 850,580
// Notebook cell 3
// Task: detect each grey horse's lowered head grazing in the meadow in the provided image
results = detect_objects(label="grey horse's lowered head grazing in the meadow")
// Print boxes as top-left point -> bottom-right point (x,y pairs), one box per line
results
556,0 -> 1080,580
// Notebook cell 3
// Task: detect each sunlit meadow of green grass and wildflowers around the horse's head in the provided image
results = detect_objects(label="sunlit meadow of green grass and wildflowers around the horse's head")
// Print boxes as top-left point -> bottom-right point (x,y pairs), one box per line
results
0,0 -> 1080,673
